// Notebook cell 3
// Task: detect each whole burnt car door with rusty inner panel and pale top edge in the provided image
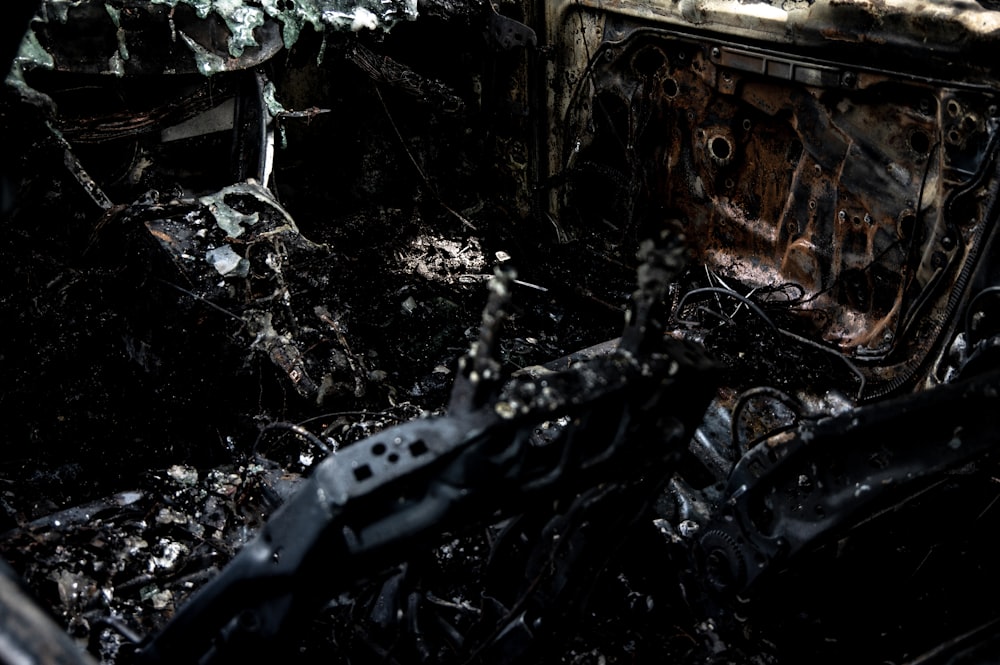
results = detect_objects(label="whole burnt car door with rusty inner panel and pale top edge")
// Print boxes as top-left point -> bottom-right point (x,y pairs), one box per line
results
546,2 -> 1000,394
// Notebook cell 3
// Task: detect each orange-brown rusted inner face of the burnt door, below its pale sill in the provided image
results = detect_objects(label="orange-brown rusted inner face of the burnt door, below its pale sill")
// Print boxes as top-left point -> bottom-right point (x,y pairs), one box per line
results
563,34 -> 995,358
